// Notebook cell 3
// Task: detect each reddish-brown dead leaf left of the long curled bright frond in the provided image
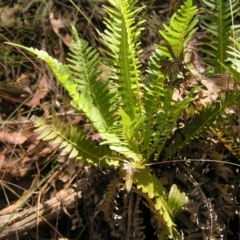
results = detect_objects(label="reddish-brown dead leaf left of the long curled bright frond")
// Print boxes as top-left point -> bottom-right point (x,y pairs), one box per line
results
27,76 -> 50,108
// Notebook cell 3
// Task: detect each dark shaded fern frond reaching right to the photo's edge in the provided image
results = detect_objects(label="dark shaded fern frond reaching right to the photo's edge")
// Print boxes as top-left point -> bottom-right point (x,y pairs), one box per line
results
166,92 -> 240,159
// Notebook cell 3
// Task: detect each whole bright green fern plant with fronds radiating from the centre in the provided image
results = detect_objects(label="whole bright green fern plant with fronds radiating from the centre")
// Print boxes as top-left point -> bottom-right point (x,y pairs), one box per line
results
6,0 -> 240,239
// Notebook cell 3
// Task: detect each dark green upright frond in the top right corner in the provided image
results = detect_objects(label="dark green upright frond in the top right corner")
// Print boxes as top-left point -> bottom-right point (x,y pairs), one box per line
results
200,0 -> 239,73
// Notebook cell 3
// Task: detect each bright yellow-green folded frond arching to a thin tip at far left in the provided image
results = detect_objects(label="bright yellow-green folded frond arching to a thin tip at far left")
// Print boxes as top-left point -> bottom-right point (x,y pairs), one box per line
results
5,44 -> 141,162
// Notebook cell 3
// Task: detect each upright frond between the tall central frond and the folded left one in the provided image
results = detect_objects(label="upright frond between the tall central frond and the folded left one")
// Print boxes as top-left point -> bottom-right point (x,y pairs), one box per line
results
67,27 -> 117,127
